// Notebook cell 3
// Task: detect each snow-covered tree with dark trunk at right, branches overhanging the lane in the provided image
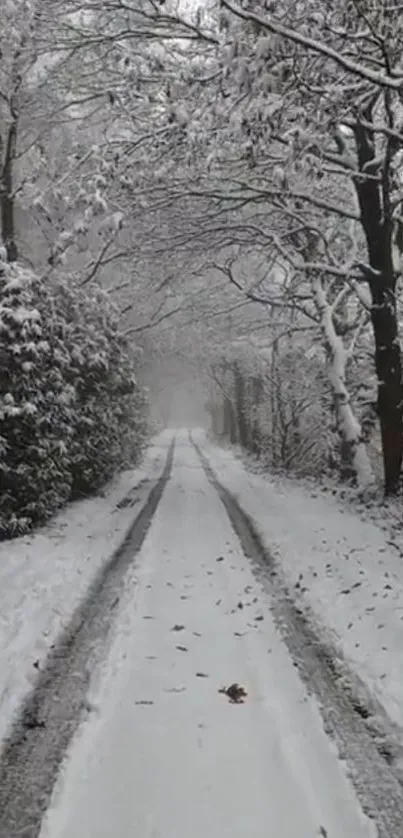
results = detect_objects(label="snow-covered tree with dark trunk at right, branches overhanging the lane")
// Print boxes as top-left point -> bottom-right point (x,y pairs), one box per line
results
117,0 -> 403,493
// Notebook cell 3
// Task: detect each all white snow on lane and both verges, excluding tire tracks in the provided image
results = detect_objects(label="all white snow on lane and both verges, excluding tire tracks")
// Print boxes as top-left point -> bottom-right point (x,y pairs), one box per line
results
0,430 -> 403,838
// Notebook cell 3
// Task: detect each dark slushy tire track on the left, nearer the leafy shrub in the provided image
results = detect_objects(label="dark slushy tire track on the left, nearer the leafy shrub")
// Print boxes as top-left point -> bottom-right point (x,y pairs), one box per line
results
0,440 -> 175,838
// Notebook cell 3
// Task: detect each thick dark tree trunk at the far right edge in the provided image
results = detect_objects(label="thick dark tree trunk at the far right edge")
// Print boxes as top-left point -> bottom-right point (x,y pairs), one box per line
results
355,119 -> 403,495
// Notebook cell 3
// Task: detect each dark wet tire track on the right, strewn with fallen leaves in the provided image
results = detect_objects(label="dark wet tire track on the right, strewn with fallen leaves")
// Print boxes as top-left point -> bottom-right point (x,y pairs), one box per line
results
194,434 -> 403,838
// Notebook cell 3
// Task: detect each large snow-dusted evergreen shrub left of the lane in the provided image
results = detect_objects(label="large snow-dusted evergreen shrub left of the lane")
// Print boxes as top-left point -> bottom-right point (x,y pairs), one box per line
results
0,265 -> 146,537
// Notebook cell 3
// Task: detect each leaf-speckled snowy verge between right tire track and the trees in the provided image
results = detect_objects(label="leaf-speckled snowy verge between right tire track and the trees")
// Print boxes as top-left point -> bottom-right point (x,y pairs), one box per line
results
199,432 -> 403,728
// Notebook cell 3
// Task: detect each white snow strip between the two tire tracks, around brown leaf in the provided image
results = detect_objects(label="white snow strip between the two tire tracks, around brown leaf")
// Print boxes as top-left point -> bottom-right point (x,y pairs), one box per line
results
41,434 -> 376,838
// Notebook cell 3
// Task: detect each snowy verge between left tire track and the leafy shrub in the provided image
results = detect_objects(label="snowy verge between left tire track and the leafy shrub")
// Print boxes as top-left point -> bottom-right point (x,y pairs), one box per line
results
0,434 -> 169,740
